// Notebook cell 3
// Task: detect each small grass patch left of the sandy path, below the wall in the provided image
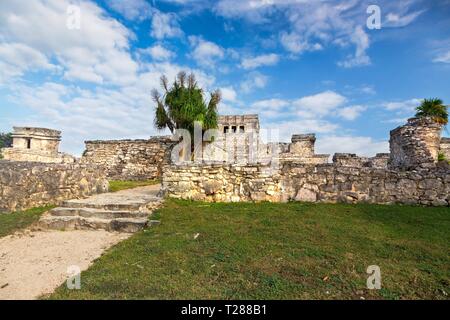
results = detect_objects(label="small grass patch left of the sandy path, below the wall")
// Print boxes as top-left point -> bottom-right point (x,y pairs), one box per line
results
0,206 -> 54,237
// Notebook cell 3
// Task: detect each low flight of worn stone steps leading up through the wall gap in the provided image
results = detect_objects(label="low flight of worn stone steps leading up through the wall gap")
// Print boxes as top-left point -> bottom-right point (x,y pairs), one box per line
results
37,185 -> 162,233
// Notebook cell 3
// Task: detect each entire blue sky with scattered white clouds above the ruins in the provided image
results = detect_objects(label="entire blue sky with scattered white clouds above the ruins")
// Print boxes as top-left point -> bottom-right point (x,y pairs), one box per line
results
0,0 -> 450,155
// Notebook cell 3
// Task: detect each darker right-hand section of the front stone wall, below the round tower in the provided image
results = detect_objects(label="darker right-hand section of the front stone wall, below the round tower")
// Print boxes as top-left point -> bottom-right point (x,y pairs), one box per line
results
282,164 -> 450,206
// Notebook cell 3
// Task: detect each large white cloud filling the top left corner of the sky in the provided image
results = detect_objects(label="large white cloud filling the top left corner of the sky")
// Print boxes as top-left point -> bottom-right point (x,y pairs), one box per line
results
0,0 -> 137,85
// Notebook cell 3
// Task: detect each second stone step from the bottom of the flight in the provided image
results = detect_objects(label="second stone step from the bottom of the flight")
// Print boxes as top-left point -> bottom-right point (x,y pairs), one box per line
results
49,207 -> 151,219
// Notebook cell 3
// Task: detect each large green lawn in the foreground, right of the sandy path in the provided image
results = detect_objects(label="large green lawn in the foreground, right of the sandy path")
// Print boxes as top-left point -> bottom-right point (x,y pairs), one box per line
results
50,200 -> 450,299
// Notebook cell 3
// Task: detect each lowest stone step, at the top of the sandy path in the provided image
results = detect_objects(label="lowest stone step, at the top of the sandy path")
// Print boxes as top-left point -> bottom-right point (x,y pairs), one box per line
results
39,215 -> 148,233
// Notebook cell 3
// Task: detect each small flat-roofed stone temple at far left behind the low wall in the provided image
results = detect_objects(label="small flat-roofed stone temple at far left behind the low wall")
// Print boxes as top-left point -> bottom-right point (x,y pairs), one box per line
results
2,127 -> 75,163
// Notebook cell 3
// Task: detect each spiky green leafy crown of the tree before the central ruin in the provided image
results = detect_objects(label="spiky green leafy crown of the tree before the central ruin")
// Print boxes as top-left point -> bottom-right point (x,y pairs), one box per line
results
152,72 -> 221,137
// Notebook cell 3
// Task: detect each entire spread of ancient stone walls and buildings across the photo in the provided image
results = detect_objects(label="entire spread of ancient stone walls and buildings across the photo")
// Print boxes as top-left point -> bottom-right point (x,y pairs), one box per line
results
0,115 -> 450,211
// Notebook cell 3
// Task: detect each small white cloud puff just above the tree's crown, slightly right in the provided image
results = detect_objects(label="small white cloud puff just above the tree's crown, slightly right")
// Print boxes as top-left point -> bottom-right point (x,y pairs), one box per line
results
189,36 -> 225,67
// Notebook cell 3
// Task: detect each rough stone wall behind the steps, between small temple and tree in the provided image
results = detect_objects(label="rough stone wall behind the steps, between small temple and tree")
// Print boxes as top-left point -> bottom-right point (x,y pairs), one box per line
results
81,137 -> 174,180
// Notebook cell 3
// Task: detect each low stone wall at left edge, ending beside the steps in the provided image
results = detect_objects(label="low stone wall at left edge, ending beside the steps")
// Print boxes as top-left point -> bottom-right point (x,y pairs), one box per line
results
0,161 -> 108,213
